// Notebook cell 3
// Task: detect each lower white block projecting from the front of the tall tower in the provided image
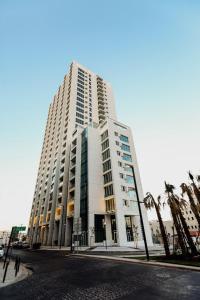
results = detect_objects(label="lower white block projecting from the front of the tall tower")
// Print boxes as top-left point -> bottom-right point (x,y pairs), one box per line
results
68,118 -> 152,246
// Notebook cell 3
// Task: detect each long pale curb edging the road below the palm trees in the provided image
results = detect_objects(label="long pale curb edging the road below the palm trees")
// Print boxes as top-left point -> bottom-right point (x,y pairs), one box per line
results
72,253 -> 200,272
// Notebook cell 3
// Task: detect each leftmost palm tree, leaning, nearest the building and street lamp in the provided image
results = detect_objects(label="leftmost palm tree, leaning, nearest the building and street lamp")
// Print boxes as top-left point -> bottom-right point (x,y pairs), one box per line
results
144,193 -> 170,256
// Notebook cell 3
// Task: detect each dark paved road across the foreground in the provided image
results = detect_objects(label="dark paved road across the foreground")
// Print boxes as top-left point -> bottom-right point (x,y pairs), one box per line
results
0,250 -> 200,300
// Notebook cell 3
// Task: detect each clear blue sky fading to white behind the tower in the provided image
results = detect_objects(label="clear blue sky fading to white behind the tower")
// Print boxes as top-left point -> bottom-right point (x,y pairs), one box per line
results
0,0 -> 200,229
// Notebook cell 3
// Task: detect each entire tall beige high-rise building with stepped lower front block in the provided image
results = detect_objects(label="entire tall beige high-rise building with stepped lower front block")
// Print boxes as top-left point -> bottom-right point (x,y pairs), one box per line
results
28,62 -> 151,246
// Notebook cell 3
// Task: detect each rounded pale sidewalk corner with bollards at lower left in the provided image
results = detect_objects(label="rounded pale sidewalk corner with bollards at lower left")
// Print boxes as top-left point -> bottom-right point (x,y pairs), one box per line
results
0,260 -> 31,288
